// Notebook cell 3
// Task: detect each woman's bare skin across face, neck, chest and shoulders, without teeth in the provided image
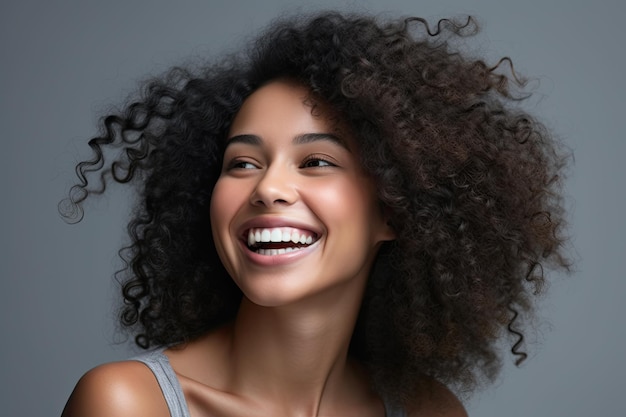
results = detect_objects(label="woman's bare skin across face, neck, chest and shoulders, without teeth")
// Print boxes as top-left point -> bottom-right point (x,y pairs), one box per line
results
63,80 -> 467,417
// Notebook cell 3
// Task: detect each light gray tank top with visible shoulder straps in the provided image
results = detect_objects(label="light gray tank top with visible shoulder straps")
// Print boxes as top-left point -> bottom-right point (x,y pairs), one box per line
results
132,350 -> 406,417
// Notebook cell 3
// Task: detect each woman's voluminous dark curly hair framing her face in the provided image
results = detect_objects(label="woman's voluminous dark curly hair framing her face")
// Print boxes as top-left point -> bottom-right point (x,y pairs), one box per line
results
60,12 -> 569,401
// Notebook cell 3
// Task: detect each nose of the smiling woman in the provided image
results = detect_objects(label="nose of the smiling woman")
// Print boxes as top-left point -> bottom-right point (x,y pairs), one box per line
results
250,164 -> 298,207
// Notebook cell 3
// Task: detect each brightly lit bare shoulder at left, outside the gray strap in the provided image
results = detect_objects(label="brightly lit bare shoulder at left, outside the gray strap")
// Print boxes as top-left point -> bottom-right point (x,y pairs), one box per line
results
62,361 -> 169,417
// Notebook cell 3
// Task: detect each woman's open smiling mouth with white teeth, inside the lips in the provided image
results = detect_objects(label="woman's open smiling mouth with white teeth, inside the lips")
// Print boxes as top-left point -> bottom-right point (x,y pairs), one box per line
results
247,227 -> 319,256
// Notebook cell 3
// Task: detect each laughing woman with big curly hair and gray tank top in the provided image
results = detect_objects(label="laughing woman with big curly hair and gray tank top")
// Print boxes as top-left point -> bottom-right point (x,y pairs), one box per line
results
63,9 -> 567,417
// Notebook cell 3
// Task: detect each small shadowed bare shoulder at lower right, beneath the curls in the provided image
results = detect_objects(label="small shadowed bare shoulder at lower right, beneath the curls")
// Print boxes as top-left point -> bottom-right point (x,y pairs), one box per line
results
407,379 -> 468,417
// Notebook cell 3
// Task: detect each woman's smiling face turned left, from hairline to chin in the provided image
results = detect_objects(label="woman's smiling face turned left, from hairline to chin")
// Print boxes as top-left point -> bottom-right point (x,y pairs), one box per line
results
211,80 -> 393,306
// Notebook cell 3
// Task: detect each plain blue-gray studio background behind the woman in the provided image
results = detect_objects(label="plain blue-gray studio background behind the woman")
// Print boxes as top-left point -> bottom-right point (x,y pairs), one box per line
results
0,0 -> 626,417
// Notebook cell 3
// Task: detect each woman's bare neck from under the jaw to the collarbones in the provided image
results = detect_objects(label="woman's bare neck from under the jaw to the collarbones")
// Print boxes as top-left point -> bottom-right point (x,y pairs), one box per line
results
229,282 -> 363,415
